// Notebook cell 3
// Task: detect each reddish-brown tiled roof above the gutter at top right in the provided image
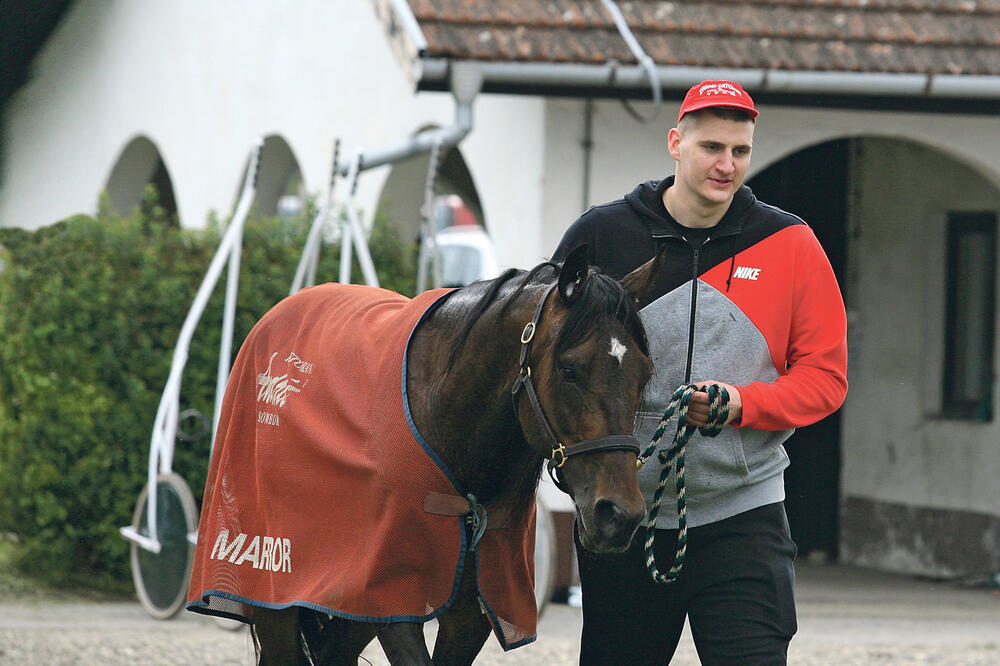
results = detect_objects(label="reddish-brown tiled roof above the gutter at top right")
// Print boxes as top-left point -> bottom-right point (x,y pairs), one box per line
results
406,0 -> 1000,76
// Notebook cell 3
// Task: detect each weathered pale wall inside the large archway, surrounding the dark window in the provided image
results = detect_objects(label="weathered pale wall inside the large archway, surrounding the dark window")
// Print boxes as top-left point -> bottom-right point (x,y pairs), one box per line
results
842,140 -> 1000,516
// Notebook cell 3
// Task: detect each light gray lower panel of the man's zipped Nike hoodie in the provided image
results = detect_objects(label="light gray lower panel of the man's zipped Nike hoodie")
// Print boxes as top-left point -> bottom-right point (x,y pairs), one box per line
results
636,280 -> 793,528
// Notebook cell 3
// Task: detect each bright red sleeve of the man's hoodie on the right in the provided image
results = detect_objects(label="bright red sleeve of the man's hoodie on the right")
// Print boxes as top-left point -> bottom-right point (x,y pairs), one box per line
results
736,227 -> 847,430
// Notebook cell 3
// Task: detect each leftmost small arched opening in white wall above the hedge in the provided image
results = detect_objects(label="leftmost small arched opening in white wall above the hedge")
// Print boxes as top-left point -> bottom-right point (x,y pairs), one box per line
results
104,136 -> 177,218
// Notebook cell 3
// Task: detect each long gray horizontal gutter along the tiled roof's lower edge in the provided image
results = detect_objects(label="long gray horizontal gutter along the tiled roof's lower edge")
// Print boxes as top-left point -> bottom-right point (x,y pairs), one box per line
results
417,58 -> 1000,100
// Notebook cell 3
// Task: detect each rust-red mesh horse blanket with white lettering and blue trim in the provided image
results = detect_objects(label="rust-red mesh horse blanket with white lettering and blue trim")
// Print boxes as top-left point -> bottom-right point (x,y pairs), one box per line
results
188,284 -> 537,650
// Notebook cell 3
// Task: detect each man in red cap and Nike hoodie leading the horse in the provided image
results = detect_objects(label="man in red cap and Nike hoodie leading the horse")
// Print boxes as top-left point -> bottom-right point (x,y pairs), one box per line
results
554,81 -> 847,665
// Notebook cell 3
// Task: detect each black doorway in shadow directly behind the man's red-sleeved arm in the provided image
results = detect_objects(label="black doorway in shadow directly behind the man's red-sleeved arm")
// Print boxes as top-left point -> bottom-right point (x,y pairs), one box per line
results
747,139 -> 850,559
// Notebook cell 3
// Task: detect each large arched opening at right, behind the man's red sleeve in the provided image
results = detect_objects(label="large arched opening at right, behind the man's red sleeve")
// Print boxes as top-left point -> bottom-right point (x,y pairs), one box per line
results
747,136 -> 1000,575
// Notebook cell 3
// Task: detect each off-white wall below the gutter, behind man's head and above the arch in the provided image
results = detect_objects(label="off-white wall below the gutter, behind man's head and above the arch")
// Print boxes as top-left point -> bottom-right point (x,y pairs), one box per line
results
542,98 -> 1000,253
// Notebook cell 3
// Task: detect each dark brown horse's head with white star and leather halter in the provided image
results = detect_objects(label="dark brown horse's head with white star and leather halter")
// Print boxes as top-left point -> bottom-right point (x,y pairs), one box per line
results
513,247 -> 662,552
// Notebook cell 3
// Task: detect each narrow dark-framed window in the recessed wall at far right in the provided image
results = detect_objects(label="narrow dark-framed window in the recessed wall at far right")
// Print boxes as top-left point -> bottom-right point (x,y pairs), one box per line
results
942,212 -> 997,421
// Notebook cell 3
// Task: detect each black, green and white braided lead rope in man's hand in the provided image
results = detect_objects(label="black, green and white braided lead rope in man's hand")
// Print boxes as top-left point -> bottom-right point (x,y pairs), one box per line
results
638,384 -> 729,584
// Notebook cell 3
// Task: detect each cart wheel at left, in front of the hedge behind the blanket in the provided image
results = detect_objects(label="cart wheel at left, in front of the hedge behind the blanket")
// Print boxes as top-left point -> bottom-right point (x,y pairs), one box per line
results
131,472 -> 198,620
